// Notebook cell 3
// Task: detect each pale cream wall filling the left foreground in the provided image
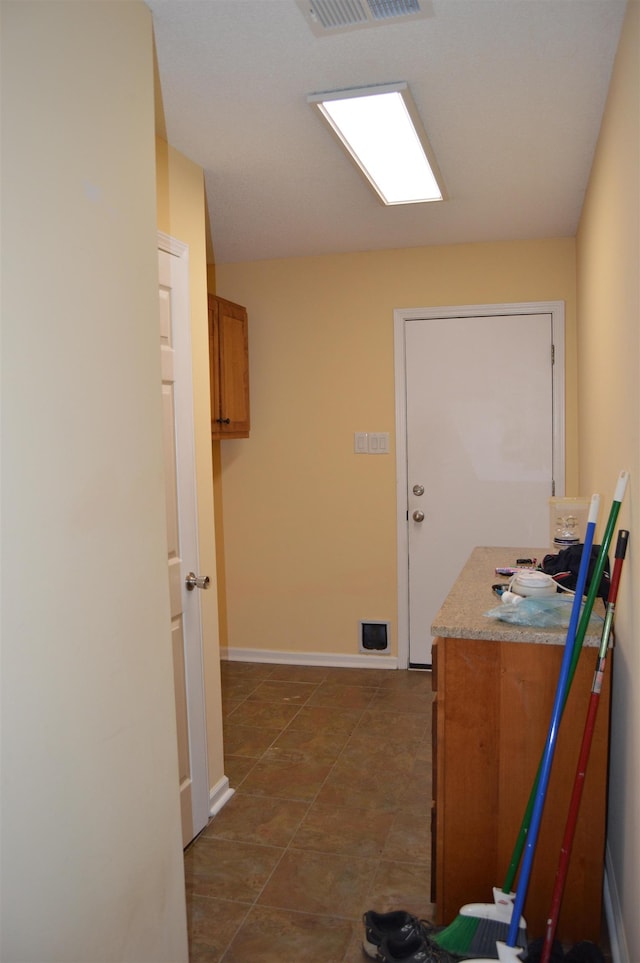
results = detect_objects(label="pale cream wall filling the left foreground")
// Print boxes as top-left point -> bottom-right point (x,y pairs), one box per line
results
0,0 -> 188,963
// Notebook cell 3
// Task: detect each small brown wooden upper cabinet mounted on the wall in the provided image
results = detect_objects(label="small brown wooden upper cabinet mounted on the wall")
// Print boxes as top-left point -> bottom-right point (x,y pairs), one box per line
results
209,294 -> 250,440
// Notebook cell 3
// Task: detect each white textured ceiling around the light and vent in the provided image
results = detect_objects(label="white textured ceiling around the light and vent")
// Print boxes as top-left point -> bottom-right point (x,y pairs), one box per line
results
147,0 -> 626,264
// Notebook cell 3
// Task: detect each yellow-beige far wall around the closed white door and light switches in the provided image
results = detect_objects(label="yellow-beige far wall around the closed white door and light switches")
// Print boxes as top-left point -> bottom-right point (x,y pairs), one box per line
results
216,239 -> 577,655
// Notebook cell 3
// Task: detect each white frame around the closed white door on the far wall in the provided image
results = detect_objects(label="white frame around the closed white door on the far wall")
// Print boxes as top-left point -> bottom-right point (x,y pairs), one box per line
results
393,301 -> 565,669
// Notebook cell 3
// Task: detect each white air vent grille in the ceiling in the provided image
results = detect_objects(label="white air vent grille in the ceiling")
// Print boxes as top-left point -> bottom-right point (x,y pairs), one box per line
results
296,0 -> 431,37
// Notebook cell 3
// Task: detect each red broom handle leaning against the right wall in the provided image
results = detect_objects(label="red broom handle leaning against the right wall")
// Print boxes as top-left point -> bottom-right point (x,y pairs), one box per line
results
540,529 -> 629,963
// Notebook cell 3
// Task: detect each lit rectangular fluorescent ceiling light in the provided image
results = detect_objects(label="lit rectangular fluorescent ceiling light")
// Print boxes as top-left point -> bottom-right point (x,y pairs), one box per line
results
307,83 -> 445,204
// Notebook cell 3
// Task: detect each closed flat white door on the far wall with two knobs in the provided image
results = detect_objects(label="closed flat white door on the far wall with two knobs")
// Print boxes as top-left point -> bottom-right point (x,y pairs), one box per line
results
396,308 -> 564,666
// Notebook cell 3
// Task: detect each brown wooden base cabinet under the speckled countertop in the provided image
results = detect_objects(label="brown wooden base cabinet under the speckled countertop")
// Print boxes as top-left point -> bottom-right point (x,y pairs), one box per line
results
432,638 -> 612,943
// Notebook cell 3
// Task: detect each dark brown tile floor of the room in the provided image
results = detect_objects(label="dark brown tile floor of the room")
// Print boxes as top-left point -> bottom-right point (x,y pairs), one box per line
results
185,662 -> 433,963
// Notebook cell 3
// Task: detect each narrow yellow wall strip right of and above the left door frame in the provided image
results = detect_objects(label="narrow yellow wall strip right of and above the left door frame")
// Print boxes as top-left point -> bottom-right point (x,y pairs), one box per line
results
156,138 -> 224,790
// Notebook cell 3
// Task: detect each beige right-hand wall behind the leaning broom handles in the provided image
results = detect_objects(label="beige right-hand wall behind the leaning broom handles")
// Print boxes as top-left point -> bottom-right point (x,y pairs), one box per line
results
577,0 -> 640,963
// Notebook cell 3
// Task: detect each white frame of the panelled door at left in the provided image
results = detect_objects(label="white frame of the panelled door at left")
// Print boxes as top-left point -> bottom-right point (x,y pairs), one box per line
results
158,231 -> 209,827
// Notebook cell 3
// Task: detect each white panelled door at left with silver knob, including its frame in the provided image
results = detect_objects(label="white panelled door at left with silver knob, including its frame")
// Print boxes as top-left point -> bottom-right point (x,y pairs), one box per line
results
158,238 -> 209,846
